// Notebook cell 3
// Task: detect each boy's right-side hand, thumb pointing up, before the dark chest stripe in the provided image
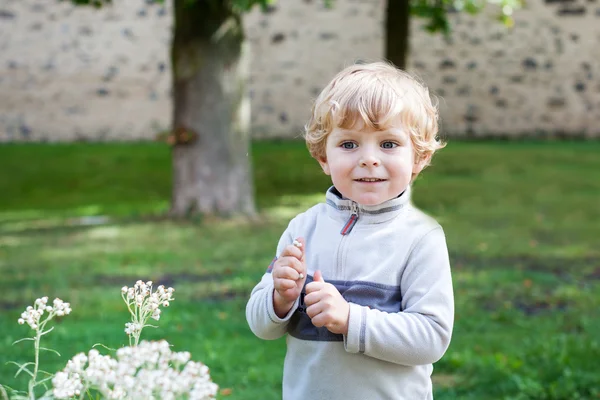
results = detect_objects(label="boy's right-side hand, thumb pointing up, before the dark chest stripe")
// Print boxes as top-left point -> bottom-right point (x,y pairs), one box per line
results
304,271 -> 350,335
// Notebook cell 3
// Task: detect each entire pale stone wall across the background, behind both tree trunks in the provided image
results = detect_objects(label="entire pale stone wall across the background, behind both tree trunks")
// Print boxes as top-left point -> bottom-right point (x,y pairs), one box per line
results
0,0 -> 600,141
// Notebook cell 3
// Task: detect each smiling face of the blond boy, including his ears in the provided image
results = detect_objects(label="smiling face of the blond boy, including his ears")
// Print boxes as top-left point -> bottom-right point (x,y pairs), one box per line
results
319,122 -> 426,206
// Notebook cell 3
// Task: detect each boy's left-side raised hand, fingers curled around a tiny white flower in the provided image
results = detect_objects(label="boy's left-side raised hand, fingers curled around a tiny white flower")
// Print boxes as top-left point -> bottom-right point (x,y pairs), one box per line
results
271,238 -> 306,318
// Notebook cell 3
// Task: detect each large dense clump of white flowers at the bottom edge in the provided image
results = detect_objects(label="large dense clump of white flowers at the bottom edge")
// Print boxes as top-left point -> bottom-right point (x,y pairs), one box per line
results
52,340 -> 218,400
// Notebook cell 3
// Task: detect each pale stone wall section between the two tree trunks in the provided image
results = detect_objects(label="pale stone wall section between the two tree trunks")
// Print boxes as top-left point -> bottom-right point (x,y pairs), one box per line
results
245,0 -> 385,137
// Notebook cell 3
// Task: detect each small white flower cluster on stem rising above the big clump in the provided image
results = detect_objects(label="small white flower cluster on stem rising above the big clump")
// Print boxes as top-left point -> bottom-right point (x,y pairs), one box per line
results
121,280 -> 175,344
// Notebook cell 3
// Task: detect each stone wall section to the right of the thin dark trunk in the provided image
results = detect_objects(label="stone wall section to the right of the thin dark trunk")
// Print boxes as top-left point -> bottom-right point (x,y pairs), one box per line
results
410,0 -> 600,137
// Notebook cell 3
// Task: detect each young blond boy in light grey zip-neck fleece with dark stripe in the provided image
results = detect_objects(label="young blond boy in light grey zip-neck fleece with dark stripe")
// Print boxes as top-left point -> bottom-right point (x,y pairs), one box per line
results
246,62 -> 454,400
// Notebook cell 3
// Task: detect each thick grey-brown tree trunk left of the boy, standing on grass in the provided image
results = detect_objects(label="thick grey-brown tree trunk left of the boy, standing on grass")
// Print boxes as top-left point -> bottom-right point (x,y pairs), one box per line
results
171,0 -> 255,217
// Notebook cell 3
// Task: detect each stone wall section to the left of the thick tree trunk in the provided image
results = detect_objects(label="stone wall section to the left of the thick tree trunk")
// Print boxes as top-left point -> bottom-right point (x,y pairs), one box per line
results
0,0 -> 172,141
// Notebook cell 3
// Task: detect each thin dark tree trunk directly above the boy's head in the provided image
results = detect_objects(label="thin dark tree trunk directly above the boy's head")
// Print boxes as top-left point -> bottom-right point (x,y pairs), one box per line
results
385,0 -> 410,69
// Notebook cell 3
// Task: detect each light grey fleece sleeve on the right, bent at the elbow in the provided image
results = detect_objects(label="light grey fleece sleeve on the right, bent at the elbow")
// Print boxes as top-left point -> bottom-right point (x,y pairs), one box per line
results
344,226 -> 454,366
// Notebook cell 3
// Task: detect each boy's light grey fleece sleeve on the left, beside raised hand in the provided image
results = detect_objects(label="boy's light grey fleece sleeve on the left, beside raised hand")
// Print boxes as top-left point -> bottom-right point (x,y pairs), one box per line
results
246,220 -> 299,340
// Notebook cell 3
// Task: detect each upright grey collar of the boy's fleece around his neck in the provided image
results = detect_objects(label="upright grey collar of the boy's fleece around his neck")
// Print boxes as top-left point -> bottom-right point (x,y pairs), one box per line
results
325,186 -> 411,224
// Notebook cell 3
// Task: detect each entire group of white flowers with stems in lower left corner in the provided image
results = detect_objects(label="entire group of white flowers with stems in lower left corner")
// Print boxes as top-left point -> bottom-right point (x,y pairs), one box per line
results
8,281 -> 218,400
